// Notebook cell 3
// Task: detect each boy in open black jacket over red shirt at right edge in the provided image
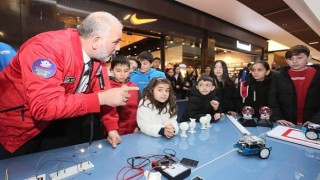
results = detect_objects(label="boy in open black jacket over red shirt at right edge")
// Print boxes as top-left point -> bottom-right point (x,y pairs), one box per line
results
269,45 -> 320,126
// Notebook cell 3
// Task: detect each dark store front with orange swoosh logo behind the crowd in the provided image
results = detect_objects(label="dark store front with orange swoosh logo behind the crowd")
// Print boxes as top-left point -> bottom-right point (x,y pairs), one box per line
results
0,0 -> 268,76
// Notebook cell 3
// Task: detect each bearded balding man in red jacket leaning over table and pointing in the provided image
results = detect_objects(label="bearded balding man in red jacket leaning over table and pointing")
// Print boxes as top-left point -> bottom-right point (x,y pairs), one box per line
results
0,12 -> 137,159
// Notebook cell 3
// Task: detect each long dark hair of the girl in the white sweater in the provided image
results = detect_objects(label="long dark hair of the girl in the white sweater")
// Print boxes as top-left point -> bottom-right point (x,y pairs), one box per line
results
140,78 -> 178,117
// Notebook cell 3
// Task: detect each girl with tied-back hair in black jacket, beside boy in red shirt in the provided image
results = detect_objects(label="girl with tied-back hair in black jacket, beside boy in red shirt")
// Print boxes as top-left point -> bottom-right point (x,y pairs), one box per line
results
236,61 -> 272,117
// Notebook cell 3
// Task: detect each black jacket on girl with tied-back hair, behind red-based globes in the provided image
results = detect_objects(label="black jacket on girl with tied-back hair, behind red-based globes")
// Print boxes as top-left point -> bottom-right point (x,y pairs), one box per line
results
235,75 -> 271,118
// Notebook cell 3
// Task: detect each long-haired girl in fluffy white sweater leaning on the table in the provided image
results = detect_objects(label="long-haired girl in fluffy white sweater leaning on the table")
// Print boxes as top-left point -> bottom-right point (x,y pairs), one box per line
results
137,78 -> 179,138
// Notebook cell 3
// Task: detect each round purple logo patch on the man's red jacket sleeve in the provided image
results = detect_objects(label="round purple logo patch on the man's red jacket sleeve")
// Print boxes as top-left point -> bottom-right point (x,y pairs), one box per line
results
32,59 -> 57,78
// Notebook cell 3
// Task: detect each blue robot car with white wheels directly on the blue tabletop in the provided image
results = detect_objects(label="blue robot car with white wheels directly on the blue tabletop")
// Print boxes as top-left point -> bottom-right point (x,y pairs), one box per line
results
233,135 -> 272,159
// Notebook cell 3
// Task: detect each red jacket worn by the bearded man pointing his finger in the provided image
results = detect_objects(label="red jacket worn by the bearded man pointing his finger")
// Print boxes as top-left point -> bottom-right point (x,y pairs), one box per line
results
0,29 -> 117,152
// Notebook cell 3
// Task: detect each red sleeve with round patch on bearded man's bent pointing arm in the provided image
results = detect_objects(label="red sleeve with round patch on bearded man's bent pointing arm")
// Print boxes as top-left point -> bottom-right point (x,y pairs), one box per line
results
19,41 -> 100,121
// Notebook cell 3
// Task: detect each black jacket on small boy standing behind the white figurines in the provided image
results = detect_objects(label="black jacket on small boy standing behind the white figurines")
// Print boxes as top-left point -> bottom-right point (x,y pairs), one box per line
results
181,87 -> 220,122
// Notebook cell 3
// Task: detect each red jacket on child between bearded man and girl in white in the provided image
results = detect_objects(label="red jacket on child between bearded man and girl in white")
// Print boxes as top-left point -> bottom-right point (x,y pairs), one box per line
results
104,79 -> 139,135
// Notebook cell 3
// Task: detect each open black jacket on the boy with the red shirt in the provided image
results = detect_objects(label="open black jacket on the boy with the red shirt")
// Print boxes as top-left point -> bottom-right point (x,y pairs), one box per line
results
269,66 -> 320,124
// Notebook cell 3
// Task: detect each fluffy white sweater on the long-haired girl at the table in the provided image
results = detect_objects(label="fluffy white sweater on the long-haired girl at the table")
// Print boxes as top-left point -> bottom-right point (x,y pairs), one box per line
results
137,99 -> 179,137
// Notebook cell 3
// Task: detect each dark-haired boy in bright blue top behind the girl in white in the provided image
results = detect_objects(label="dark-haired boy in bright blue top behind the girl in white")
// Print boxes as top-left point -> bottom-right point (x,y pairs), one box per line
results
130,51 -> 166,94
